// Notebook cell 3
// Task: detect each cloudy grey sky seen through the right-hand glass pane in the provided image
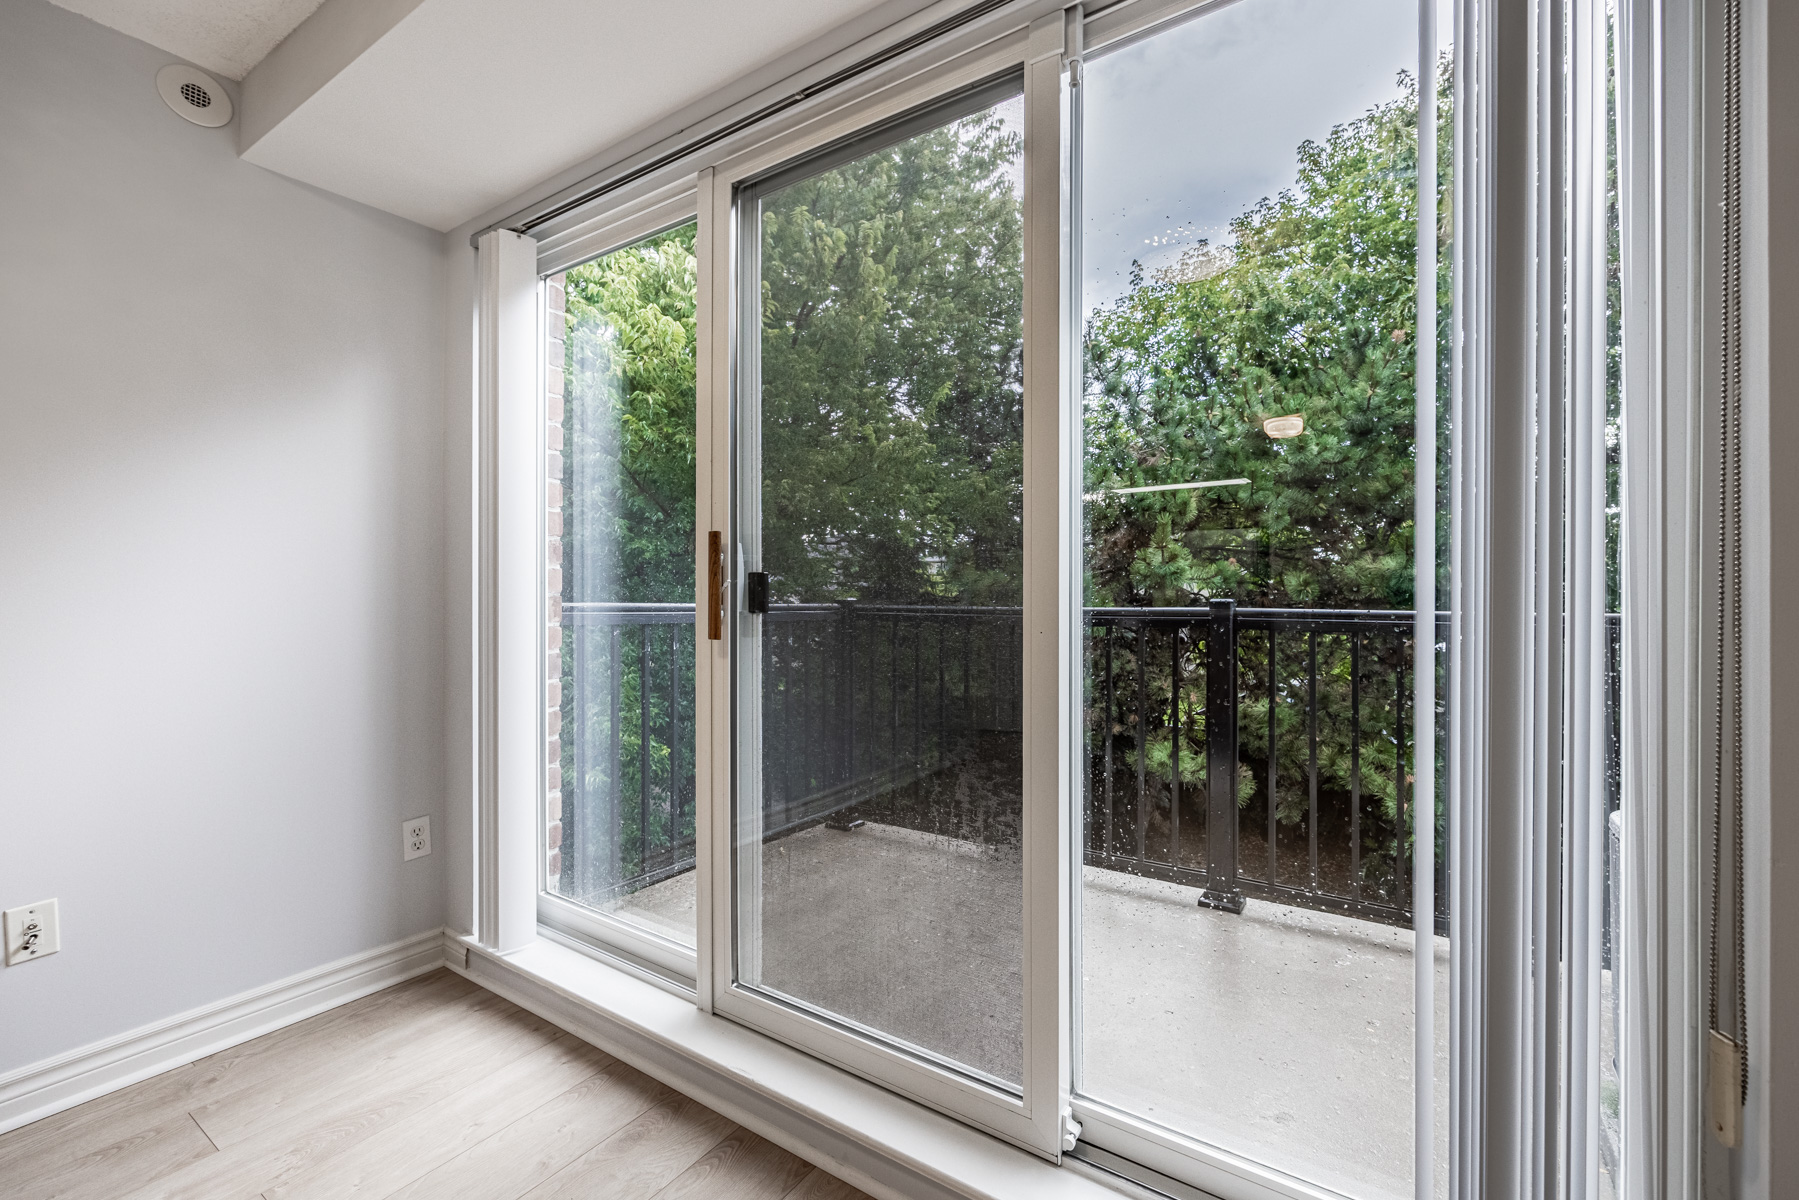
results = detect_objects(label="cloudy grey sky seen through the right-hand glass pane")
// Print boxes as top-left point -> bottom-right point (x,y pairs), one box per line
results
1081,0 -> 1418,311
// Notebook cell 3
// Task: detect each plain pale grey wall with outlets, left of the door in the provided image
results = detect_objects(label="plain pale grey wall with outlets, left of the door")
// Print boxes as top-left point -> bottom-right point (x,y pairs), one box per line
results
0,0 -> 448,1074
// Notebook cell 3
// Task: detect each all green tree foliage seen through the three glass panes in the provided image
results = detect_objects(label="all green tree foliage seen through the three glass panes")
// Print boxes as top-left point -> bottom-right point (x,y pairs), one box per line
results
567,65 -> 1452,895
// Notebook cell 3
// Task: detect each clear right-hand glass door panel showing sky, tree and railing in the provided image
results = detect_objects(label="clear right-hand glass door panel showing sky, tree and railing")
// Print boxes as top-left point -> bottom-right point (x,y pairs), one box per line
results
1076,0 -> 1450,1198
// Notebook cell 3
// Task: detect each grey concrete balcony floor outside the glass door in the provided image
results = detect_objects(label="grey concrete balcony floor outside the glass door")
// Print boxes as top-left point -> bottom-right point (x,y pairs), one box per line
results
615,822 -> 1448,1200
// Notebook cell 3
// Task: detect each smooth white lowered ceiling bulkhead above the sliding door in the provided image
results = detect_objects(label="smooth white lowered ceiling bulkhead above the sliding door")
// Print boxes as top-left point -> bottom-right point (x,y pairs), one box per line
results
245,0 -> 925,230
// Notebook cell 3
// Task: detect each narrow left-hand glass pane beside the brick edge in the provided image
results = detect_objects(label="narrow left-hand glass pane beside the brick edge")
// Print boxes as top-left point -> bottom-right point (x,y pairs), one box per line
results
547,223 -> 696,948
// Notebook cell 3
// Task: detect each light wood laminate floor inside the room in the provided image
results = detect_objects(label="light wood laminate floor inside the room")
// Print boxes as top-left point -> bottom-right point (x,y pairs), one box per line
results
0,972 -> 865,1200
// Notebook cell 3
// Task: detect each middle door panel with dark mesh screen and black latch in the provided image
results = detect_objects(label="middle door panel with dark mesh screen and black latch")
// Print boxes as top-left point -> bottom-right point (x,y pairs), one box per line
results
734,85 -> 1024,1092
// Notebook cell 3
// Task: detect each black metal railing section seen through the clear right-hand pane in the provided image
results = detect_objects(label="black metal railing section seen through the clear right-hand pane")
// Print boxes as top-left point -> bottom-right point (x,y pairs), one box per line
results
1087,601 -> 1448,932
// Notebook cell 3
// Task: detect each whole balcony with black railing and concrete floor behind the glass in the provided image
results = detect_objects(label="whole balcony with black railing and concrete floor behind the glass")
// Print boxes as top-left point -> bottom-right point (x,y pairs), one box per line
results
546,601 -> 1617,1196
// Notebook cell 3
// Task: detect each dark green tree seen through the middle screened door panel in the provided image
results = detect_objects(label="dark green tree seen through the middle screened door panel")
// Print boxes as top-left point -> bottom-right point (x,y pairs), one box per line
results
761,110 -> 1024,604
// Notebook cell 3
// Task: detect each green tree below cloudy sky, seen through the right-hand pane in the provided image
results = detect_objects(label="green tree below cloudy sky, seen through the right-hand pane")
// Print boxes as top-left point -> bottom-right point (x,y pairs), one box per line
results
1085,63 -> 1452,900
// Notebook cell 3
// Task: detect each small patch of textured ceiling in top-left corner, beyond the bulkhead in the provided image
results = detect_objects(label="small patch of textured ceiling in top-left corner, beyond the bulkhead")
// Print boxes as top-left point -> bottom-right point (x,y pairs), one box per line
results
50,0 -> 322,79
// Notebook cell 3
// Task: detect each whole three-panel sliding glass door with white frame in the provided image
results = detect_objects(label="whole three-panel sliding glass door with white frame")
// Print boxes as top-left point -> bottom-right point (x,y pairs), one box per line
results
514,0 -> 1633,1200
